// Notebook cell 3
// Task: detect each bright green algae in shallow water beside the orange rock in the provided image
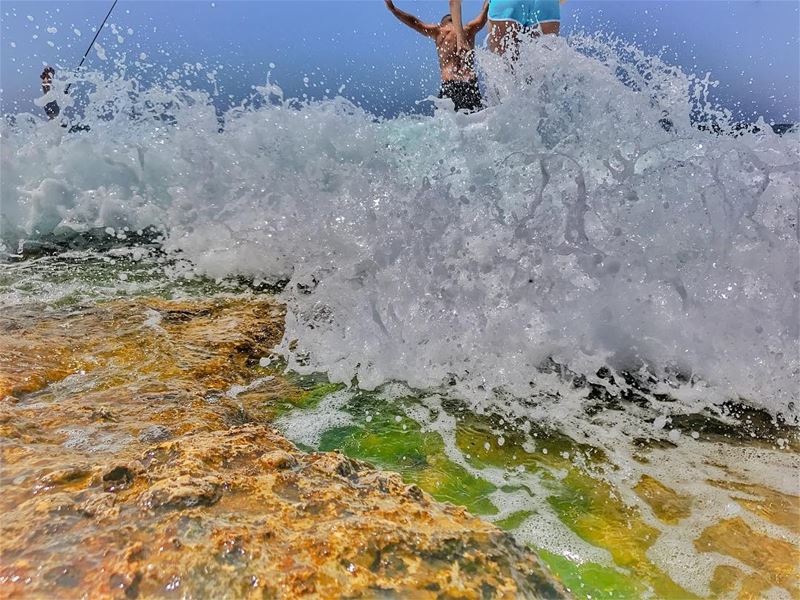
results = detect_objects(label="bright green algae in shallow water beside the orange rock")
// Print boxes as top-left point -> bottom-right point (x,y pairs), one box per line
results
276,380 -> 708,598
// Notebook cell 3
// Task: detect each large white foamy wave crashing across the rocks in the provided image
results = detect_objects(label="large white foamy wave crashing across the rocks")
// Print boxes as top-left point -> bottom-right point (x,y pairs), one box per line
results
0,32 -> 800,419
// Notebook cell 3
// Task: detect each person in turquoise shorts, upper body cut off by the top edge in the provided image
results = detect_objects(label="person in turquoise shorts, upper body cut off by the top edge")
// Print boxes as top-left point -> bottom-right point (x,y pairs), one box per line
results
450,0 -> 561,58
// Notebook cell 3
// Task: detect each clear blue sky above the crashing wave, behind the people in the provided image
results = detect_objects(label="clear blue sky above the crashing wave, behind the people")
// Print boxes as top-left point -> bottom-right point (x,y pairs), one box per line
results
0,0 -> 800,122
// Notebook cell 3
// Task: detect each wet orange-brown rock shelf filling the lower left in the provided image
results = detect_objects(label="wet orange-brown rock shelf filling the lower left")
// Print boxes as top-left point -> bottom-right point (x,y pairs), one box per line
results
0,300 -> 567,598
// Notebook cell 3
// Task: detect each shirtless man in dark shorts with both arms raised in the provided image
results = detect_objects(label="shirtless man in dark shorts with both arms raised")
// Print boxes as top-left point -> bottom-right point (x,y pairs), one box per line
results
384,0 -> 490,112
